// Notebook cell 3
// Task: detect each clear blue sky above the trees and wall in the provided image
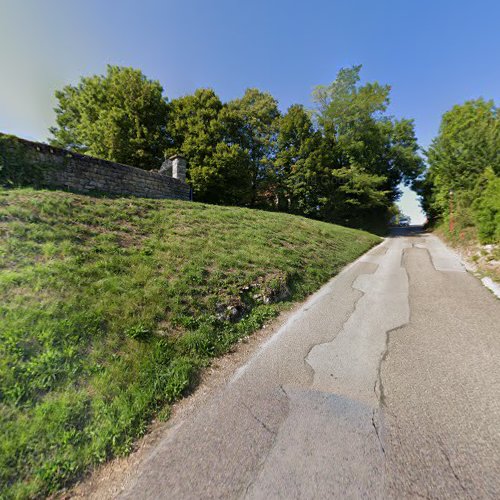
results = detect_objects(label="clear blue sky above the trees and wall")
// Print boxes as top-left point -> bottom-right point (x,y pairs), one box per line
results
0,0 -> 500,222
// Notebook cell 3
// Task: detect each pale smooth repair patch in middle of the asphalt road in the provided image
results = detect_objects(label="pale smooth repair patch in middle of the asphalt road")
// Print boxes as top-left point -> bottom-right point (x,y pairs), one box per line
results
307,239 -> 409,406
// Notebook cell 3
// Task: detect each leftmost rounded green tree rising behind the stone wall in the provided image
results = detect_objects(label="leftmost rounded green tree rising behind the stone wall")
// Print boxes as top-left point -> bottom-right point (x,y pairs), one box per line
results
50,65 -> 168,170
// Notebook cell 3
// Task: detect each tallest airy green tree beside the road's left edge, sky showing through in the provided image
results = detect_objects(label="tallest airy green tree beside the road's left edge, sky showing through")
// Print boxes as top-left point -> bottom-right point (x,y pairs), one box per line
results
313,66 -> 423,225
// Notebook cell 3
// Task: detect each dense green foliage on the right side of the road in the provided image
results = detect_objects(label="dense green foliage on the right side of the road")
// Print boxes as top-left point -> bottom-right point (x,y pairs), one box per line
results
420,99 -> 500,243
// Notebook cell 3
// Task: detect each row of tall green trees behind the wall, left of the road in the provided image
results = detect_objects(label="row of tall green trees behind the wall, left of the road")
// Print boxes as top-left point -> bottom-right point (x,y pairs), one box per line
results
51,66 -> 423,231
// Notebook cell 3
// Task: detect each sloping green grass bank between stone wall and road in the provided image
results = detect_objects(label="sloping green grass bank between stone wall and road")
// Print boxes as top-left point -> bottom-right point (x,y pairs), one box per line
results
0,189 -> 378,498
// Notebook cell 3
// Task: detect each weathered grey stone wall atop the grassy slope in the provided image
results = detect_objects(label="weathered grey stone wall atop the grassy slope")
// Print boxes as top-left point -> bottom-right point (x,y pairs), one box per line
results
0,136 -> 190,200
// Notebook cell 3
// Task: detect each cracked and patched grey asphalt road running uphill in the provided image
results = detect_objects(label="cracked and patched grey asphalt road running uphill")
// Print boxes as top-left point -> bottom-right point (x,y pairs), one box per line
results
120,230 -> 500,499
